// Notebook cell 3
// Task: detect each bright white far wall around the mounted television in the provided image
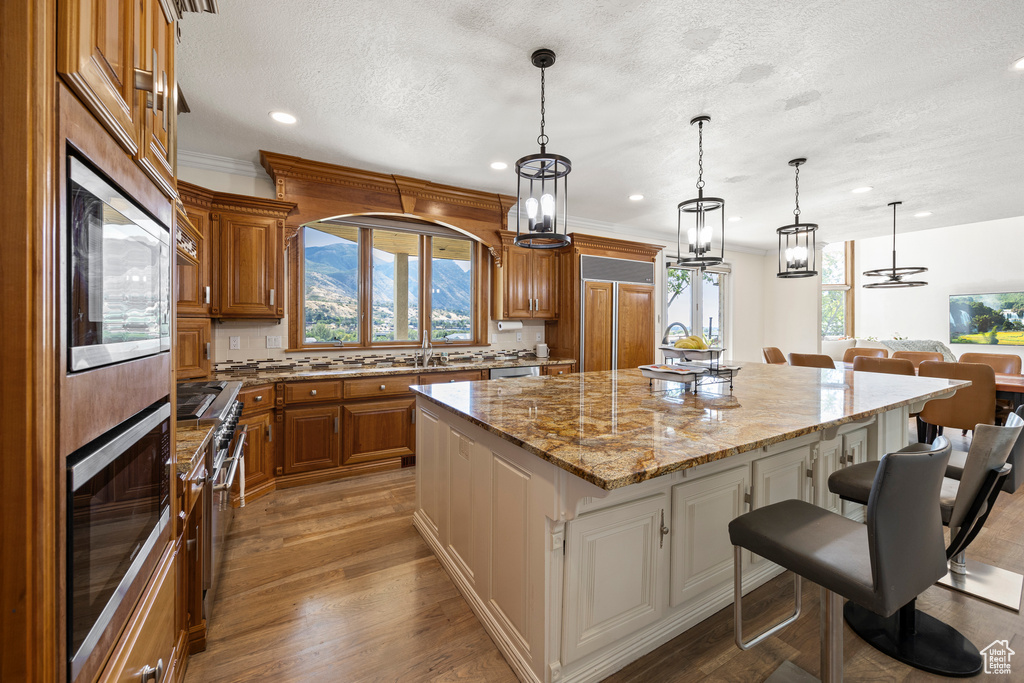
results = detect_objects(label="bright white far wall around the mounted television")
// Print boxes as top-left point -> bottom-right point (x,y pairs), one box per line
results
855,216 -> 1024,366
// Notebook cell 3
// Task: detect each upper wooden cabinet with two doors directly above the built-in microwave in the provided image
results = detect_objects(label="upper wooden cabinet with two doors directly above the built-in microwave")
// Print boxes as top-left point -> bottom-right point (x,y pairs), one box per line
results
57,0 -> 177,197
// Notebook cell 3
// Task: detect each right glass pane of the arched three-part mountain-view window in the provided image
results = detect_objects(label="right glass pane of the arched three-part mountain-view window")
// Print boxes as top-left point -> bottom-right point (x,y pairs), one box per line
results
430,238 -> 473,341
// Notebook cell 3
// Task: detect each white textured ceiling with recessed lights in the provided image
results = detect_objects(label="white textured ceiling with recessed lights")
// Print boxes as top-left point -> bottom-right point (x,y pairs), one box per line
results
178,0 -> 1024,249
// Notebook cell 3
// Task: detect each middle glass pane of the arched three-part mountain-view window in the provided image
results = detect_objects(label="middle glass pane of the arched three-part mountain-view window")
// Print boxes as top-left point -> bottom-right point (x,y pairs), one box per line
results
371,229 -> 420,341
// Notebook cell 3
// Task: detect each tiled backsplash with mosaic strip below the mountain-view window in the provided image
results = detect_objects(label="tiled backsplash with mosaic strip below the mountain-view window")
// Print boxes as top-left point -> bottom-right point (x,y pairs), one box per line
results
213,321 -> 544,372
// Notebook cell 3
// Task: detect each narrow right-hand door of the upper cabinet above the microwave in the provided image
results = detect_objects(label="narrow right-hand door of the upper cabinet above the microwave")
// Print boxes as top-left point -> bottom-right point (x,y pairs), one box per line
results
136,0 -> 178,197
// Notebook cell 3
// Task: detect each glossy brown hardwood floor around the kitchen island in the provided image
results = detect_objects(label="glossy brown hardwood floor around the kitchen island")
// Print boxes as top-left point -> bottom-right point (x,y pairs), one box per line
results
185,435 -> 1024,683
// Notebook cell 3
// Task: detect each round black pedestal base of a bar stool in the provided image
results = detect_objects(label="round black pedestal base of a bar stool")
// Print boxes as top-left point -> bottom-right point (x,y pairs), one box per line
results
843,601 -> 982,678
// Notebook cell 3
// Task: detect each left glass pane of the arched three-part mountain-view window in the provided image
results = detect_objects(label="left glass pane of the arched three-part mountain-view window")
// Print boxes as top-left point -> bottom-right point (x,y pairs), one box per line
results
303,223 -> 359,343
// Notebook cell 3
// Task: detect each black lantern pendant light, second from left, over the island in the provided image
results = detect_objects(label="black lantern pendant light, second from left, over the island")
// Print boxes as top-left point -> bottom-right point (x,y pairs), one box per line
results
676,116 -> 725,269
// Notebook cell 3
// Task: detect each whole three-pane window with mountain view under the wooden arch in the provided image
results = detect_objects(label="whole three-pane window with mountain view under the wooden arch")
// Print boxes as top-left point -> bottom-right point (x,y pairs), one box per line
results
302,221 -> 477,346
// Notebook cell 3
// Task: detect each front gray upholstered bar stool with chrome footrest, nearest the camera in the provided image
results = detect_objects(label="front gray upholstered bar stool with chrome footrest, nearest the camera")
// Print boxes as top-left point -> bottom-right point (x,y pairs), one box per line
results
729,439 -> 958,683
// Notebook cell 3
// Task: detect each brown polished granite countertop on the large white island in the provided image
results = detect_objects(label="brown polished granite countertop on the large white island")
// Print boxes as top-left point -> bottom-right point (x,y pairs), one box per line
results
414,364 -> 970,489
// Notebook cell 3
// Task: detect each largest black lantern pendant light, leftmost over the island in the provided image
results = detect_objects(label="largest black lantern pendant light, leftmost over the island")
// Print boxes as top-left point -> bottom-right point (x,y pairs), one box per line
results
515,48 -> 572,249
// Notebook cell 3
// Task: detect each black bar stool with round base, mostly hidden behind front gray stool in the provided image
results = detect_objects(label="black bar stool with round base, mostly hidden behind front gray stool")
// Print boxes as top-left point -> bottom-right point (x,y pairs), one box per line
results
828,416 -> 1024,676
